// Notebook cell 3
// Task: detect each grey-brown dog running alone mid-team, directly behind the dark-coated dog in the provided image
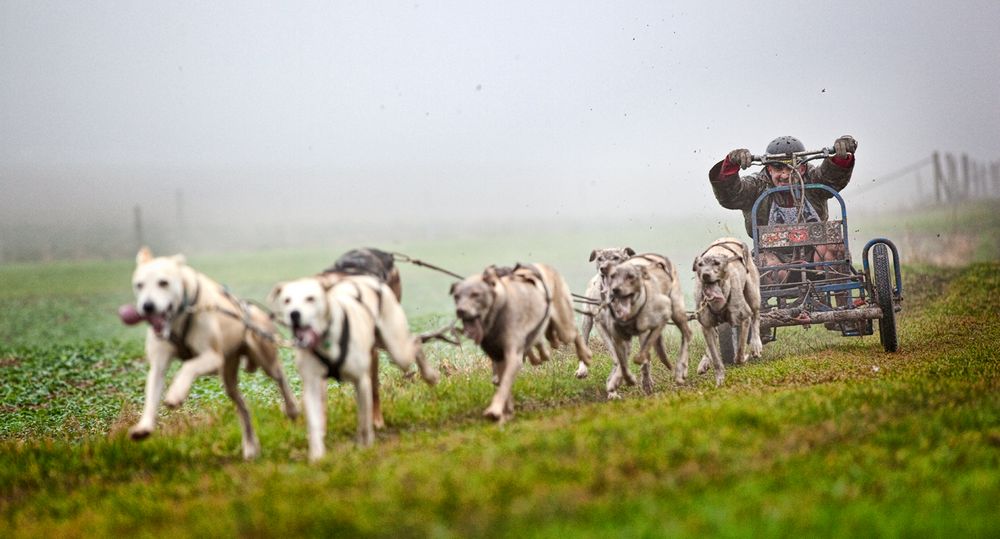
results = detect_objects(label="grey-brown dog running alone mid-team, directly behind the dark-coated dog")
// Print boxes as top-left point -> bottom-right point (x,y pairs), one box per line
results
451,264 -> 590,422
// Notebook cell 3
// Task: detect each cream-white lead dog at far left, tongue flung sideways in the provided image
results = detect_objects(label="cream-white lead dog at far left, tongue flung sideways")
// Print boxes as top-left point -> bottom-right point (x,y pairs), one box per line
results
125,247 -> 298,459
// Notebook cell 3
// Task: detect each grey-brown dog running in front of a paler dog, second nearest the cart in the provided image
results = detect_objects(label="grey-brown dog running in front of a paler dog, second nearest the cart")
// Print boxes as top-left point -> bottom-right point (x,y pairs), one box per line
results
598,254 -> 691,399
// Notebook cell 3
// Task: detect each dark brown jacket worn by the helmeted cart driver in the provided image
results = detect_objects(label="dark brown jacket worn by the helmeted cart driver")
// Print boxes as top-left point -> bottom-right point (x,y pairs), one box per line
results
708,159 -> 854,235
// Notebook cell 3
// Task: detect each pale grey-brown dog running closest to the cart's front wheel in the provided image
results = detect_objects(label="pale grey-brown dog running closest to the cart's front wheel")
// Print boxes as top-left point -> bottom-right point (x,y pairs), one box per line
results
691,238 -> 763,385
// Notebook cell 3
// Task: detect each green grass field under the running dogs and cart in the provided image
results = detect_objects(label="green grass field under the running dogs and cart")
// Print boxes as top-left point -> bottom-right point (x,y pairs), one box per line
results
0,210 -> 1000,537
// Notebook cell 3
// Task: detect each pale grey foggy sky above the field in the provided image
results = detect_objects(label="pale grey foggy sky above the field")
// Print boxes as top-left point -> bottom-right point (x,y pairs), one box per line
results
0,0 -> 1000,235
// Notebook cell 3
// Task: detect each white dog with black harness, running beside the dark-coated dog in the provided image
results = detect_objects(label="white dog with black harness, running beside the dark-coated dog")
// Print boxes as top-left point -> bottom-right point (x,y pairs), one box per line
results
269,276 -> 438,460
